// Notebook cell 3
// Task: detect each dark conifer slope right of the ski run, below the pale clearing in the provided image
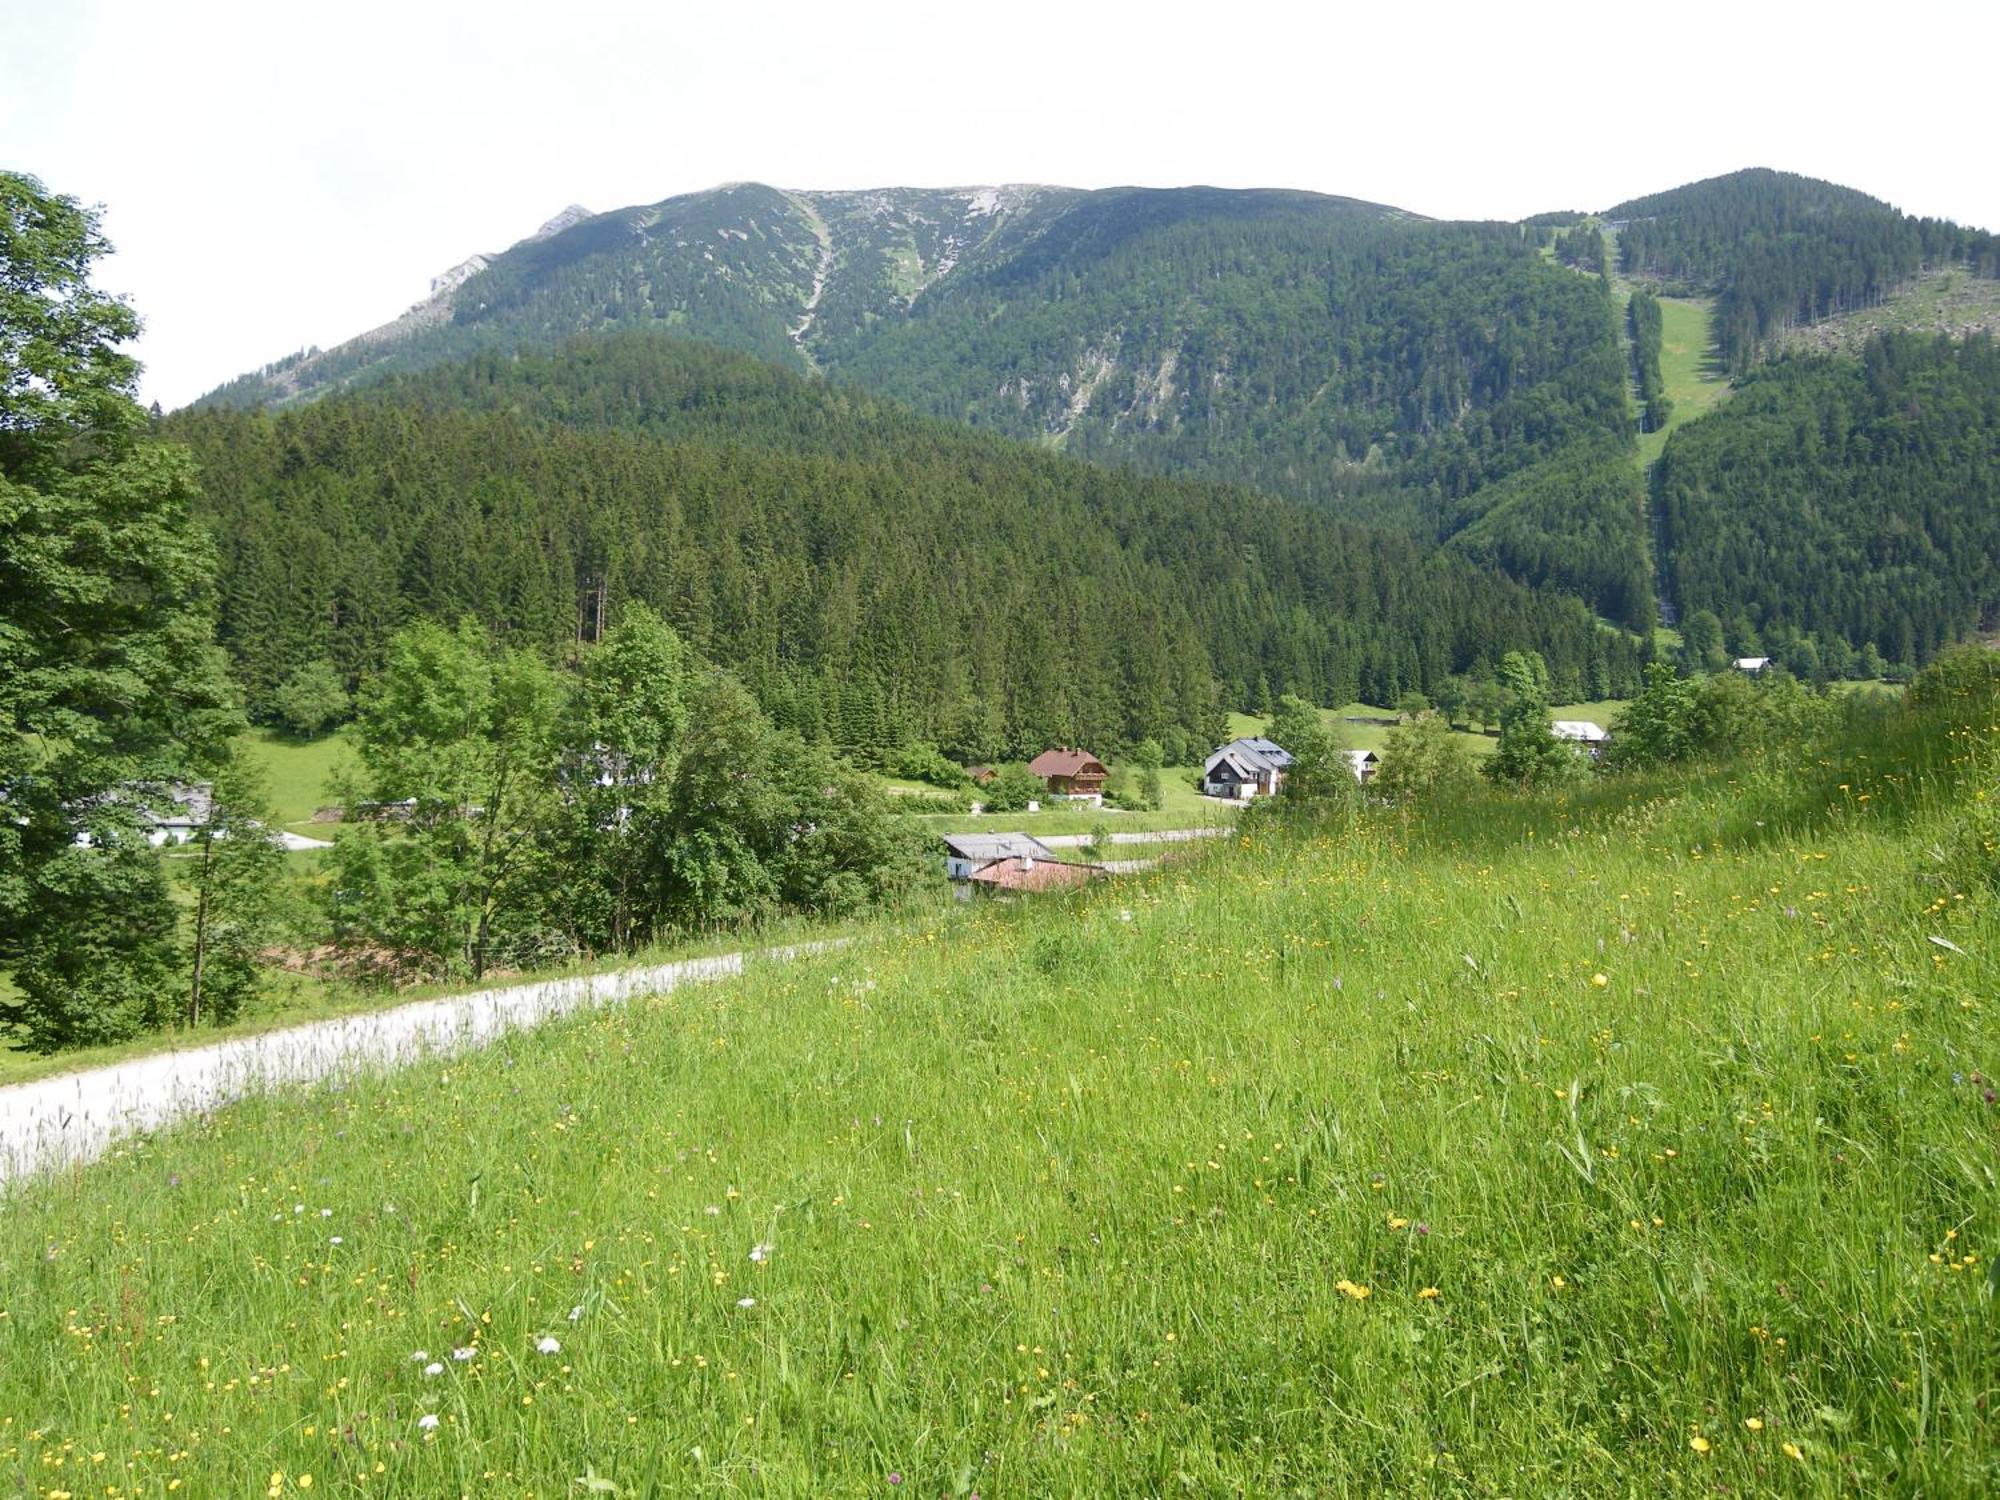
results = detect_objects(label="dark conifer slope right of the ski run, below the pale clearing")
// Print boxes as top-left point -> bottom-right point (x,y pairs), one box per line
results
1660,336 -> 2000,662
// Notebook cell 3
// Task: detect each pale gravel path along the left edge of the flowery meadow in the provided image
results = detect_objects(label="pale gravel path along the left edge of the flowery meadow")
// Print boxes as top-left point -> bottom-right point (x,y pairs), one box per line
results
0,940 -> 844,1182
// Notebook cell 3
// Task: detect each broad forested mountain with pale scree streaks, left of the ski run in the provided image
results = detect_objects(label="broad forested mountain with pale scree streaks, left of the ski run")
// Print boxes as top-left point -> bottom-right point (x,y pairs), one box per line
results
199,184 -> 1626,520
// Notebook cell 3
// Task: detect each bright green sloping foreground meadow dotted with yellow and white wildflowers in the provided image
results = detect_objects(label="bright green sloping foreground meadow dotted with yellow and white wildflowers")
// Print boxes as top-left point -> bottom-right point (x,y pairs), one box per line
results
0,688 -> 2000,1500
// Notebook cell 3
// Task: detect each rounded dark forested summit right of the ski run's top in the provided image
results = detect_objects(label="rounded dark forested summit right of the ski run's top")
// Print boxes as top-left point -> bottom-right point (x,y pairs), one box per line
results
1606,168 -> 2000,374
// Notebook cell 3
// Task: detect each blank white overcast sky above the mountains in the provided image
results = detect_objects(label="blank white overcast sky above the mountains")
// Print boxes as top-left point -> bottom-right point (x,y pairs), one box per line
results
0,0 -> 2000,406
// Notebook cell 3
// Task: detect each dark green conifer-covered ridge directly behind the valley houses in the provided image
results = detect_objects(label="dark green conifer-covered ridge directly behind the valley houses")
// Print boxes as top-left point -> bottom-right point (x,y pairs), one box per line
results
168,336 -> 1638,756
